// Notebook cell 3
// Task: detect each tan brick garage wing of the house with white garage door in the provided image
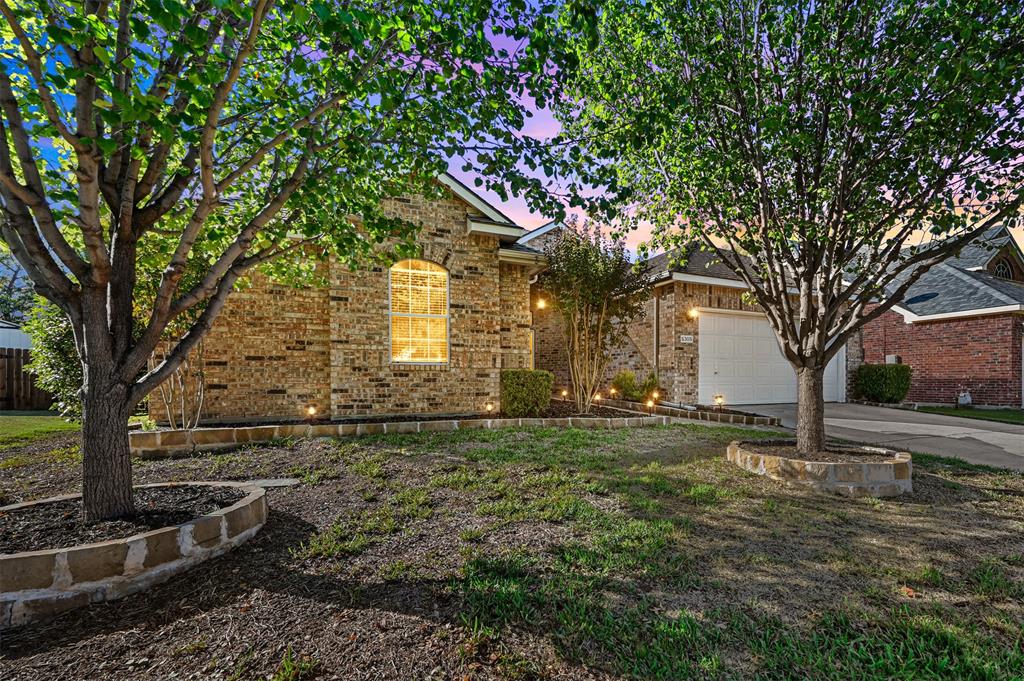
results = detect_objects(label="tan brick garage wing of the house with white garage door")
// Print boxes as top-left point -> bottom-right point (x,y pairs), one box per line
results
519,223 -> 847,405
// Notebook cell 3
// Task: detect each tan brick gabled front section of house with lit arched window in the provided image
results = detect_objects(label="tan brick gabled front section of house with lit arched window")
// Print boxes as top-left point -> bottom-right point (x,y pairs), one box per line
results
151,176 -> 542,423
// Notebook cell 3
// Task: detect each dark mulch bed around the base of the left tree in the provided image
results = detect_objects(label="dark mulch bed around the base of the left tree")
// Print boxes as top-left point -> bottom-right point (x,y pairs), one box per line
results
0,485 -> 245,553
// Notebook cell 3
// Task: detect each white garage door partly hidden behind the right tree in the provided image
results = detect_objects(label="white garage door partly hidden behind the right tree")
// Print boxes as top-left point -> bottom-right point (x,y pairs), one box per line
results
697,310 -> 846,405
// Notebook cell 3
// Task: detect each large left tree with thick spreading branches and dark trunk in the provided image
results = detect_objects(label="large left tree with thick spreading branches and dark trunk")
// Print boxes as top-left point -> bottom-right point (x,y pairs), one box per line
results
0,0 -> 585,519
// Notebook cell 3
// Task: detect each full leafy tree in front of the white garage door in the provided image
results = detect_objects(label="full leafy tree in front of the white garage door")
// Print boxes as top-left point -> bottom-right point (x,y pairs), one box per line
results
559,0 -> 1024,453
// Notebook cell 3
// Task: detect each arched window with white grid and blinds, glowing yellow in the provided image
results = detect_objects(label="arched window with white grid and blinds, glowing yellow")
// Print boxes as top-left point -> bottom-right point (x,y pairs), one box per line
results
390,260 -> 449,364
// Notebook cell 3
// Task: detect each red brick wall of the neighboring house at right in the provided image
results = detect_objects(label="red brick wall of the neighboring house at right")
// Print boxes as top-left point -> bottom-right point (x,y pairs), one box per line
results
861,311 -> 1024,407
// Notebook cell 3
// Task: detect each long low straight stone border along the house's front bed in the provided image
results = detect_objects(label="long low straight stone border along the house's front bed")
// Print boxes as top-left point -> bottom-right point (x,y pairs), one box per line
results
129,415 -> 675,459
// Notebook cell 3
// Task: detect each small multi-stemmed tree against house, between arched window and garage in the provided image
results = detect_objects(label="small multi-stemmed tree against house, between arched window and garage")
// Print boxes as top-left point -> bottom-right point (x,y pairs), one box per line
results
539,218 -> 650,414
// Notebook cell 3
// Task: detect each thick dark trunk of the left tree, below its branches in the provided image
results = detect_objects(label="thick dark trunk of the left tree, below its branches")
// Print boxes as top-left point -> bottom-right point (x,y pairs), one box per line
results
82,372 -> 135,520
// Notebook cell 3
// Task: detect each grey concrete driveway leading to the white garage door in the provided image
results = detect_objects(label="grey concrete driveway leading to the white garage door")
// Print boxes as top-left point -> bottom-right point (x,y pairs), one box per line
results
738,402 -> 1024,470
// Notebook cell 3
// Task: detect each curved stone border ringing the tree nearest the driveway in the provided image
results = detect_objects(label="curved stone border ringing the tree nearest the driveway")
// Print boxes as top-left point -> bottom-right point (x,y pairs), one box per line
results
725,440 -> 913,497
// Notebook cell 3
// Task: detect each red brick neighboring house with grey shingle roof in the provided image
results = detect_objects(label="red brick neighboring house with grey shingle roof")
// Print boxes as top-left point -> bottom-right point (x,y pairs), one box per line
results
848,227 -> 1024,407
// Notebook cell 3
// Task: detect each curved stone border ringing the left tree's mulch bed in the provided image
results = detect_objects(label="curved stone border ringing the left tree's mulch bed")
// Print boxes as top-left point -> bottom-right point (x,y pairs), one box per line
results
0,482 -> 267,631
